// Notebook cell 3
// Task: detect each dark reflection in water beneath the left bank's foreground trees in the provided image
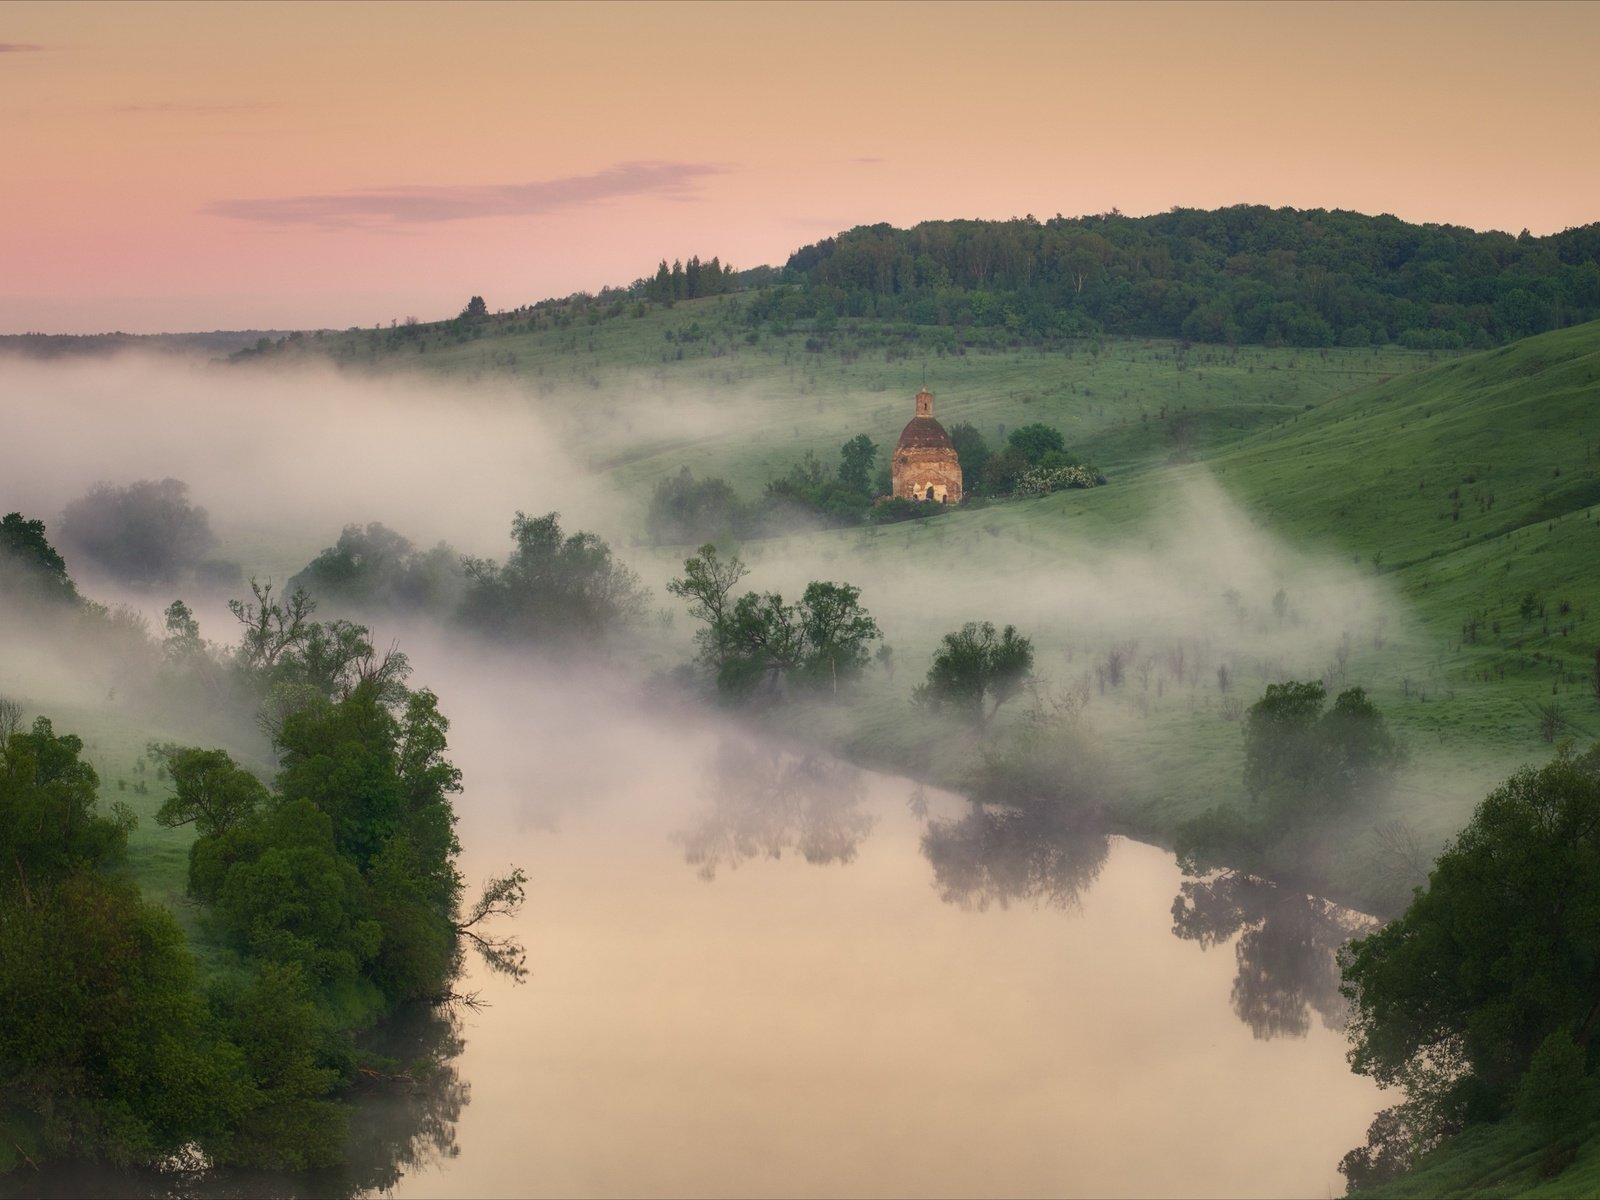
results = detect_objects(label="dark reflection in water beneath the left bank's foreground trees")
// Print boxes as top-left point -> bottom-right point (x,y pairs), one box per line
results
10,1005 -> 472,1200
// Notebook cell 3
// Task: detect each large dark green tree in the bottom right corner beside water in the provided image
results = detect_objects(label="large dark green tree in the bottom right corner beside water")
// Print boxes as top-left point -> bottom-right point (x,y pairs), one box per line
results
1342,746 -> 1600,1131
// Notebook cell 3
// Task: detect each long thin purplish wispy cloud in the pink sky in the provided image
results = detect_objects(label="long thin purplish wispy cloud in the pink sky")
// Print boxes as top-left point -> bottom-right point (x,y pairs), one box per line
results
202,162 -> 731,226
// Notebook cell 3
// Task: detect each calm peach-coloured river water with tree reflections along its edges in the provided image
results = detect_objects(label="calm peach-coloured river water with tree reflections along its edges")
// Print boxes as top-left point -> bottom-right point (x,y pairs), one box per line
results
374,672 -> 1392,1197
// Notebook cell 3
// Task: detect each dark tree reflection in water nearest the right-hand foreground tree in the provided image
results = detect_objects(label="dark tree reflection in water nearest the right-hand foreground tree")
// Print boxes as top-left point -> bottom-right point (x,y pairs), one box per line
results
1173,870 -> 1373,1040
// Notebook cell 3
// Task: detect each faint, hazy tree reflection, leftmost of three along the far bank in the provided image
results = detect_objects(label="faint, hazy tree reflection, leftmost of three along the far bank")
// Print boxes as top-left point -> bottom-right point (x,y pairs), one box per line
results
677,738 -> 872,880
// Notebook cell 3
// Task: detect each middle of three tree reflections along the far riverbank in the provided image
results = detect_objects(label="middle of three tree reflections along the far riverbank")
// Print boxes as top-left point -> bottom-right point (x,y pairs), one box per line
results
922,803 -> 1110,912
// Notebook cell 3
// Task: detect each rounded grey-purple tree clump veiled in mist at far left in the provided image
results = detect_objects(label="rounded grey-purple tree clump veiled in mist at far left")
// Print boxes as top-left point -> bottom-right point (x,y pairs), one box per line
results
59,478 -> 216,584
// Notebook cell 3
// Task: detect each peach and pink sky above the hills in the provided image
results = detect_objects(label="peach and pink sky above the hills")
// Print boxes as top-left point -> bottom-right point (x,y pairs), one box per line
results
0,0 -> 1600,333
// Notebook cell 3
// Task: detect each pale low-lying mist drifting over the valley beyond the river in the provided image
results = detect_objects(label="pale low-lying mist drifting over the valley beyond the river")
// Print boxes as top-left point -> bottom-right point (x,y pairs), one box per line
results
0,357 -> 1452,857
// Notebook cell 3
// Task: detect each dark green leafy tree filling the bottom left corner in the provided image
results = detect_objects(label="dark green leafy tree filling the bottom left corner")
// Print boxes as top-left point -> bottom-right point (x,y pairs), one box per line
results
0,717 -> 232,1171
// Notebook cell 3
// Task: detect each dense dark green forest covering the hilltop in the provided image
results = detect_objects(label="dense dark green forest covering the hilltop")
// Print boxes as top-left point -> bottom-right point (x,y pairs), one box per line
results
755,205 -> 1600,349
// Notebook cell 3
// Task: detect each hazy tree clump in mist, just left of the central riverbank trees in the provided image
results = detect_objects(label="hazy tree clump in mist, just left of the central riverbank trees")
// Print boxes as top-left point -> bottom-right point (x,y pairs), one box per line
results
461,512 -> 645,642
